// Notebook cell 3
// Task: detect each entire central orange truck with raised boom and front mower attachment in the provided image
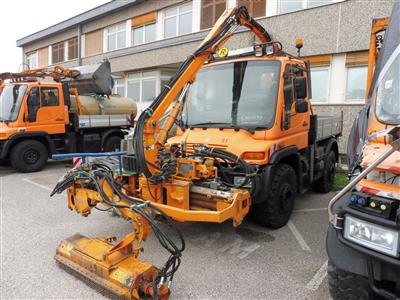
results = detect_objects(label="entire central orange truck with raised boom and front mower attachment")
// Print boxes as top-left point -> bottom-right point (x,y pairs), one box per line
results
52,6 -> 342,299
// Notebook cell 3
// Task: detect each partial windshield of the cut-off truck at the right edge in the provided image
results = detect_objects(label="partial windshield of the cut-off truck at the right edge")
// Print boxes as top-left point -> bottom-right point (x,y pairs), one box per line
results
376,51 -> 400,124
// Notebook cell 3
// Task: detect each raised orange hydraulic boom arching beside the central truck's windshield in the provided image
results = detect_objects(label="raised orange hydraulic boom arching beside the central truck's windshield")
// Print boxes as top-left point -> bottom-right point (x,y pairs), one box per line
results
134,6 -> 272,178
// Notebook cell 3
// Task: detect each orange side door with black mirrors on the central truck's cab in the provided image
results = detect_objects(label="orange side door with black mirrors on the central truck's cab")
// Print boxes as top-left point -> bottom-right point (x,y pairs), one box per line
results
282,63 -> 310,149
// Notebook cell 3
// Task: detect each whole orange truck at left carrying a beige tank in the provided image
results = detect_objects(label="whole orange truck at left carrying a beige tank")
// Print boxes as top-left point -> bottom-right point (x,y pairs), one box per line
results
0,62 -> 136,172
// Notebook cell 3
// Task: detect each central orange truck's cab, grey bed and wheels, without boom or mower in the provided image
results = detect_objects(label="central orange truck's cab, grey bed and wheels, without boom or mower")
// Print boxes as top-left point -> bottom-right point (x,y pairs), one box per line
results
168,45 -> 342,228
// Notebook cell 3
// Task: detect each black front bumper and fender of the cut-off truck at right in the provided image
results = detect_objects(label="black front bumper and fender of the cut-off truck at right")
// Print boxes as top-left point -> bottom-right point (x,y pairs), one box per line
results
326,193 -> 400,300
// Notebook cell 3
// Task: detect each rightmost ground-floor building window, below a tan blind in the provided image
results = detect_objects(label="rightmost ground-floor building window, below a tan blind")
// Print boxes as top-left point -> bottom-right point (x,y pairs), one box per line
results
346,66 -> 368,100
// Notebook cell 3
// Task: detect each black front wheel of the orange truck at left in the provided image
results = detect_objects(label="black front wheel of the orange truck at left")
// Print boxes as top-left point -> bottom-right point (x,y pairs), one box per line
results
10,140 -> 49,173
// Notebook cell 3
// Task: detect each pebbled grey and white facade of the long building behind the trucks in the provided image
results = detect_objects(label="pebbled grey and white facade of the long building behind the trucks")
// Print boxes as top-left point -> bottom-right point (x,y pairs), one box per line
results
18,0 -> 393,153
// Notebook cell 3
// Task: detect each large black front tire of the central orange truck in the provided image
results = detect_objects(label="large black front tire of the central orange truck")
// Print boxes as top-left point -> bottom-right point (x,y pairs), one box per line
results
252,164 -> 297,229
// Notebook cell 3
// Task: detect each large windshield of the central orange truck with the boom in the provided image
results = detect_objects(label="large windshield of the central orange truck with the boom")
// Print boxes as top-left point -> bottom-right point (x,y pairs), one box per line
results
182,60 -> 280,129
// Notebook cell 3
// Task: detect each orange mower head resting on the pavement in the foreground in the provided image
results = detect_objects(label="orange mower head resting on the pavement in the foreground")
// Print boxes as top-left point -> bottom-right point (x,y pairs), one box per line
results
55,234 -> 169,299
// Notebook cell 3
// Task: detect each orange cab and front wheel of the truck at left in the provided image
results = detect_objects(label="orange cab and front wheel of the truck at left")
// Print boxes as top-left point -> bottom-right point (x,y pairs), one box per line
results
0,81 -> 69,171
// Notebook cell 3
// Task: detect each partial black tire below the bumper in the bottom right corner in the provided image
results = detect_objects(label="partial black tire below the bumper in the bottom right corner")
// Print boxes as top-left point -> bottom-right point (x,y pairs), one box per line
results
328,261 -> 376,300
